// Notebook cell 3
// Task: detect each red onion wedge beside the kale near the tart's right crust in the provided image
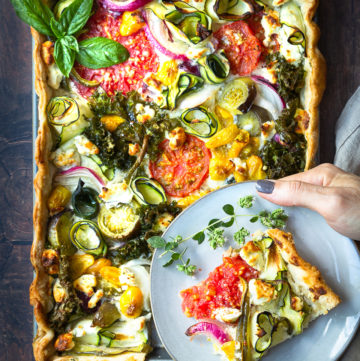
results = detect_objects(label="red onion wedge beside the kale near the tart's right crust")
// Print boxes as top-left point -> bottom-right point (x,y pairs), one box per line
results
251,75 -> 286,120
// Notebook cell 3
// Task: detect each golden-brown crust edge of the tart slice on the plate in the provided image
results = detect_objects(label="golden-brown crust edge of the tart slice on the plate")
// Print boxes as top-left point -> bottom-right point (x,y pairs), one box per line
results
267,229 -> 341,318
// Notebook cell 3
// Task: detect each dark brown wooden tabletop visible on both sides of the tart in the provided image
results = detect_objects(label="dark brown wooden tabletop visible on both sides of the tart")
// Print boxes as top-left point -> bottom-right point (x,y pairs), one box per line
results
0,0 -> 360,361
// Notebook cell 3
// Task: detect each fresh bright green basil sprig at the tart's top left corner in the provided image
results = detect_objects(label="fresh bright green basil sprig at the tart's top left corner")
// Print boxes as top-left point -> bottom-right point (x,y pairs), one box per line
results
10,0 -> 129,77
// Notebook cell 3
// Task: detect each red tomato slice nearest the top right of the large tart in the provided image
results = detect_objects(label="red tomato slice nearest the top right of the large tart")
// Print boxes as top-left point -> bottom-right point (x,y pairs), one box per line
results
214,20 -> 262,75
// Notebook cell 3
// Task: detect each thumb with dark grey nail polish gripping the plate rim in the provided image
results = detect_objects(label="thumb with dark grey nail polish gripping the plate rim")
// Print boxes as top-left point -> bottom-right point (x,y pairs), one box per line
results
256,180 -> 331,214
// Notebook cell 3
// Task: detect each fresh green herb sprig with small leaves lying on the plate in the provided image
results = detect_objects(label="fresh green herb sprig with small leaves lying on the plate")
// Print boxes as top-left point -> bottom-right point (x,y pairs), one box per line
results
148,196 -> 288,276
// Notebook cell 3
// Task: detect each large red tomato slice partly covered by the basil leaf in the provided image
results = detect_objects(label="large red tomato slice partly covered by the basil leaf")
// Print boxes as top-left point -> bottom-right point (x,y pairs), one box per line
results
75,8 -> 159,97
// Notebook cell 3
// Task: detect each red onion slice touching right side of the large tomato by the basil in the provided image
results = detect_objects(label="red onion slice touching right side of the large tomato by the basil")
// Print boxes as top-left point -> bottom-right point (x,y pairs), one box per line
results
142,9 -> 189,60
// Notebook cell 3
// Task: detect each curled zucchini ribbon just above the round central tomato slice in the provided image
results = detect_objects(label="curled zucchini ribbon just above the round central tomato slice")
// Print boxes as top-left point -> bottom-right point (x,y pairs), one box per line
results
181,107 -> 219,138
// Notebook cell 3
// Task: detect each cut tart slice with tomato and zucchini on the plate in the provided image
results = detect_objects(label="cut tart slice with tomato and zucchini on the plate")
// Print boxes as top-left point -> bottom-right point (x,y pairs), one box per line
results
181,229 -> 341,361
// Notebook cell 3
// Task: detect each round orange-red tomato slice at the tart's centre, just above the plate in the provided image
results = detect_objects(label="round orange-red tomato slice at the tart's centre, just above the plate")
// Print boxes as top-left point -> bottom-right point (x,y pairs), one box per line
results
150,134 -> 211,197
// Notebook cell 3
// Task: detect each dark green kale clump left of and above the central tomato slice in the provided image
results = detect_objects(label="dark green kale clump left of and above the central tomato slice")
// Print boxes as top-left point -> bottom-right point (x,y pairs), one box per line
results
84,92 -> 179,165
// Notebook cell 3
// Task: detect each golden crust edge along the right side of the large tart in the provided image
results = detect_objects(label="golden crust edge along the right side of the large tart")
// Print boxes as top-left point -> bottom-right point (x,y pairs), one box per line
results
295,0 -> 326,170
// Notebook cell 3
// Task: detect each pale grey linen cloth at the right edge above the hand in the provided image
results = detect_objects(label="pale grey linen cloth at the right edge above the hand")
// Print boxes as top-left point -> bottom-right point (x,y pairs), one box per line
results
334,87 -> 360,176
